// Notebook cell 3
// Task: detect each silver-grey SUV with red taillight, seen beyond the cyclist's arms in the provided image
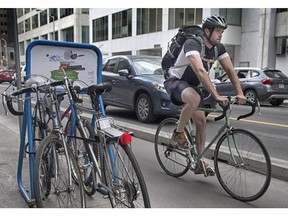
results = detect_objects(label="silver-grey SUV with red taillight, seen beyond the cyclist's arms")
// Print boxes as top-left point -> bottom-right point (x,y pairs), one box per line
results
214,67 -> 288,106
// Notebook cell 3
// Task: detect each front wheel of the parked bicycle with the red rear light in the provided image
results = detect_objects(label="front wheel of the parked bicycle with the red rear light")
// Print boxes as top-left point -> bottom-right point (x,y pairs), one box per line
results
65,117 -> 99,196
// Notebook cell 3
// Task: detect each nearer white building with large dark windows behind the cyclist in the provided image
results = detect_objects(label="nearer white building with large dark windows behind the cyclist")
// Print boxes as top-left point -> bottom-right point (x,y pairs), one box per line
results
89,8 -> 288,76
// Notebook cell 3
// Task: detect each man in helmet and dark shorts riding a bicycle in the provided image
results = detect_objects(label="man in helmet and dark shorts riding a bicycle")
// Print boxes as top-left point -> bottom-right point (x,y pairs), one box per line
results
164,15 -> 246,175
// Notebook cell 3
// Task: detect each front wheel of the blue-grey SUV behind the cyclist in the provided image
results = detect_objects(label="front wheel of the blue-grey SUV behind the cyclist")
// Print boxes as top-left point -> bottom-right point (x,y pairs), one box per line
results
135,93 -> 156,123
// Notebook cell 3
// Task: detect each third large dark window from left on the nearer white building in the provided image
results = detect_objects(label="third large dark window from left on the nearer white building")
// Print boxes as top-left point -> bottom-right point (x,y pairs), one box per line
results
137,8 -> 162,35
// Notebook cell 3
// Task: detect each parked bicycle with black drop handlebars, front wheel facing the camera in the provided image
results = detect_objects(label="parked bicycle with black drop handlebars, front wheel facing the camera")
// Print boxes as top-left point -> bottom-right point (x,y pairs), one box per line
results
2,76 -> 86,207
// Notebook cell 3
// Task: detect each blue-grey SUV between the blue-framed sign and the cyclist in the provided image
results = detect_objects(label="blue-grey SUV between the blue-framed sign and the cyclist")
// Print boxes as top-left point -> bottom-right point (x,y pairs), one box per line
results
102,55 -> 181,122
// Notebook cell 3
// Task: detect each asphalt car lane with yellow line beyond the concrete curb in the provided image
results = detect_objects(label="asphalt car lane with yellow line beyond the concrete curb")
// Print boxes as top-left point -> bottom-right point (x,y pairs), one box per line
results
106,106 -> 288,160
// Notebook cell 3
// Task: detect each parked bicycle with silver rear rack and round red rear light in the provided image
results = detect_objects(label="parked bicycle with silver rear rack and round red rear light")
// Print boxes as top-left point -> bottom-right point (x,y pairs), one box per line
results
68,83 -> 151,208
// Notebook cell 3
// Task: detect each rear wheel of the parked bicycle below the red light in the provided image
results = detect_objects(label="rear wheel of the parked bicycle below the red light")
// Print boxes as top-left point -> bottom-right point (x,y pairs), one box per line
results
102,142 -> 151,208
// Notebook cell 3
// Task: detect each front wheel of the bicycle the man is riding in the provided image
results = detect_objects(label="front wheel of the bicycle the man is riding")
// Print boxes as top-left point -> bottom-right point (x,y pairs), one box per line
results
214,129 -> 271,202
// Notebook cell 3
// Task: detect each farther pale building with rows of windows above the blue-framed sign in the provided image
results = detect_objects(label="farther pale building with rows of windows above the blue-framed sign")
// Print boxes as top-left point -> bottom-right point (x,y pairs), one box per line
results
17,8 -> 89,64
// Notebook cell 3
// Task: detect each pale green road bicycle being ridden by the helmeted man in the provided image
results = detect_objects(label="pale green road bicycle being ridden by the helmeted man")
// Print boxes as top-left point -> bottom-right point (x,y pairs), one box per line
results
154,97 -> 271,202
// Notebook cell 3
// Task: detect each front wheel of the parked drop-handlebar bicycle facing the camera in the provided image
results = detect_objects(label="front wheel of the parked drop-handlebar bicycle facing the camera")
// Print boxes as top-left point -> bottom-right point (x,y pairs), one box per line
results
34,134 -> 86,208
